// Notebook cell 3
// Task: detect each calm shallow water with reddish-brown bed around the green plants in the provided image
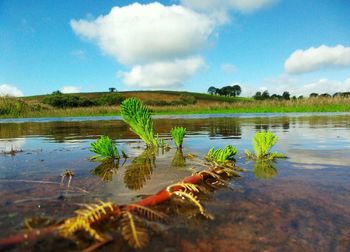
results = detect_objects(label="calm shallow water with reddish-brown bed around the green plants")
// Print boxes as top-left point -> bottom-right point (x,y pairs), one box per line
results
0,113 -> 350,251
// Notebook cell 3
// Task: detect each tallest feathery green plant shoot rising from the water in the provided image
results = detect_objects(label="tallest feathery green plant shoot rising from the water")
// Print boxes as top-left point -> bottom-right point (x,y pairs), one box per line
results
121,98 -> 158,147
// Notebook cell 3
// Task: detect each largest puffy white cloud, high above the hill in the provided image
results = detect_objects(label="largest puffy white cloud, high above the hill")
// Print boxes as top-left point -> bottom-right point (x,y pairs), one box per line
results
70,3 -> 216,66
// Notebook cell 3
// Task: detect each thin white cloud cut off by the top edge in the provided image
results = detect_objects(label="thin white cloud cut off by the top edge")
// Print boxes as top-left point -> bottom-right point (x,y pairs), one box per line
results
181,0 -> 277,12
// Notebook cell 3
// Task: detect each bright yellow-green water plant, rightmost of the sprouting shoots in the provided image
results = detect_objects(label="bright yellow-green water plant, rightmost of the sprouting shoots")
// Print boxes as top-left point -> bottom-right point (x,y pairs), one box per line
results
245,130 -> 286,160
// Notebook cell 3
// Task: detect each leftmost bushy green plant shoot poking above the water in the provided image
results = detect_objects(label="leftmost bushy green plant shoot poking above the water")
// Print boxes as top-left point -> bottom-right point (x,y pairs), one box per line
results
90,136 -> 120,161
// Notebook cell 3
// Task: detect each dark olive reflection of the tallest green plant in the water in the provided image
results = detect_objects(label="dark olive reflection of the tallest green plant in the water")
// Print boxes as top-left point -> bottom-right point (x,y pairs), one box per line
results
124,149 -> 156,190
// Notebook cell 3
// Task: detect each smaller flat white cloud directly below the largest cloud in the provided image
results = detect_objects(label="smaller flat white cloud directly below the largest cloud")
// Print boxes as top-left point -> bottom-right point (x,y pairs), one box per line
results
119,57 -> 205,88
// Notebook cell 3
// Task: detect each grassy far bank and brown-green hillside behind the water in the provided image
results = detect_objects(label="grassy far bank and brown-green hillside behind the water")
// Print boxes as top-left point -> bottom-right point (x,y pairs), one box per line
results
0,91 -> 350,118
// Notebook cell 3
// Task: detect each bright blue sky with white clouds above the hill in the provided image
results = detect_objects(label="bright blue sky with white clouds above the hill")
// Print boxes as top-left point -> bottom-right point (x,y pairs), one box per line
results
0,0 -> 350,96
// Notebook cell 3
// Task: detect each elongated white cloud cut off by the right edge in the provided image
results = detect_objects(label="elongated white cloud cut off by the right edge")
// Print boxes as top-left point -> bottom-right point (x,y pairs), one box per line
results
284,45 -> 350,74
